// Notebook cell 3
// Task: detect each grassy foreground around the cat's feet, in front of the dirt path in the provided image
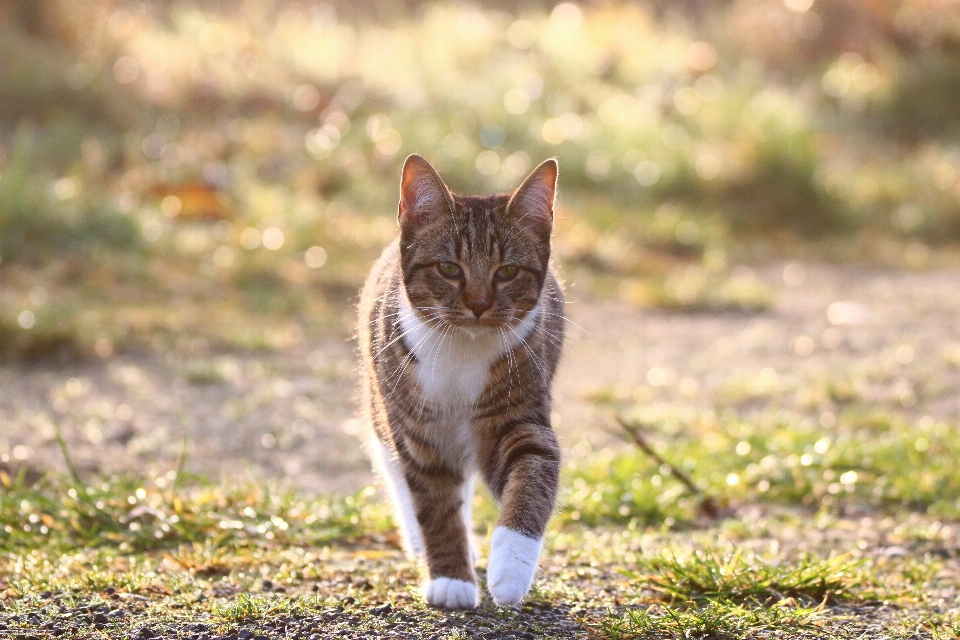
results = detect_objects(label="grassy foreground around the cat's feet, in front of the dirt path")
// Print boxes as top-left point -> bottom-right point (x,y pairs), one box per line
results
7,376 -> 958,639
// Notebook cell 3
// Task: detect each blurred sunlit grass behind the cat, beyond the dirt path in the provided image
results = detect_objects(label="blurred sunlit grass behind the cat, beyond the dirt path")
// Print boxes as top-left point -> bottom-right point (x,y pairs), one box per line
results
0,0 -> 960,360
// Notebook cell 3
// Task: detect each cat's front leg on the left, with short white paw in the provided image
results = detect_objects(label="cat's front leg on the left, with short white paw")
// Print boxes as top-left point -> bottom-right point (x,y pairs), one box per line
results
407,461 -> 480,609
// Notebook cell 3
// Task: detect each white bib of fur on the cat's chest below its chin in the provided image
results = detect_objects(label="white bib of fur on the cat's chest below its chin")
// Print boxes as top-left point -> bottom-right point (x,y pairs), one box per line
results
400,294 -> 540,412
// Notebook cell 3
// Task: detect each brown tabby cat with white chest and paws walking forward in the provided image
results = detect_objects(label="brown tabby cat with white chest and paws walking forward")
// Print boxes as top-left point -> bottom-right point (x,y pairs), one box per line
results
359,155 -> 564,609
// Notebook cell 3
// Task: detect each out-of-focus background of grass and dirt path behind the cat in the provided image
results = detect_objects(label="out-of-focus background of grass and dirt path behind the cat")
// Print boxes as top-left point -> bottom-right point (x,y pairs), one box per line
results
0,0 -> 960,504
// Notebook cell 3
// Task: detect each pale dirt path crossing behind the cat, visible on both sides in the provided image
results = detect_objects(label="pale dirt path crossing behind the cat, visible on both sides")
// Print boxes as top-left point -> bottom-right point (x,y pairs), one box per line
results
0,264 -> 960,492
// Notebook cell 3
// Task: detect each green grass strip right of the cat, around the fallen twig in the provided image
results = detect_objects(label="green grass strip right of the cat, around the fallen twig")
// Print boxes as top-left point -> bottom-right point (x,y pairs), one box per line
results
563,407 -> 960,525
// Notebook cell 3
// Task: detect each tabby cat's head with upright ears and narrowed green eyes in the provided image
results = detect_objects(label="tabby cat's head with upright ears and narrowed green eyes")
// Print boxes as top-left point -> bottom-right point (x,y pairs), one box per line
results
399,155 -> 557,328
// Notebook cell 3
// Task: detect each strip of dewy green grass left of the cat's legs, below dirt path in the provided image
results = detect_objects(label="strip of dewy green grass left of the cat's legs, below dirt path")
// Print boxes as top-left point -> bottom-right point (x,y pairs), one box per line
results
0,472 -> 387,553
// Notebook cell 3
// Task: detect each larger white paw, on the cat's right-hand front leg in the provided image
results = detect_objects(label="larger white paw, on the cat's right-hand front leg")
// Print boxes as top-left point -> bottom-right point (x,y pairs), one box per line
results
487,527 -> 543,606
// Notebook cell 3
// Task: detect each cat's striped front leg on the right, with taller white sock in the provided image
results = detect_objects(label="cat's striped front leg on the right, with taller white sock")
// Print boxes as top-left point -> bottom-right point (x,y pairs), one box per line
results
487,423 -> 560,605
